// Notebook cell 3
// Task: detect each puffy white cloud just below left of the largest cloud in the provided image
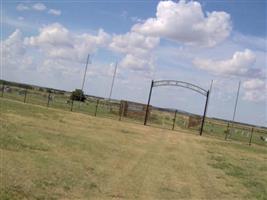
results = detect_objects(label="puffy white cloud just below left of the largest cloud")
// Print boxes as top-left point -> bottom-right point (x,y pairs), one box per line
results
110,32 -> 159,71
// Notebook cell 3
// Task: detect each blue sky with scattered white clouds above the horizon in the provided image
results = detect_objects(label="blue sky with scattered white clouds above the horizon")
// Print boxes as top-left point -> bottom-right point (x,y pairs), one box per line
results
0,0 -> 267,126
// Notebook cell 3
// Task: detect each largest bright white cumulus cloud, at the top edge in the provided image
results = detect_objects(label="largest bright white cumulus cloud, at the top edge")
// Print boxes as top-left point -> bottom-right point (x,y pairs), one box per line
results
132,0 -> 232,46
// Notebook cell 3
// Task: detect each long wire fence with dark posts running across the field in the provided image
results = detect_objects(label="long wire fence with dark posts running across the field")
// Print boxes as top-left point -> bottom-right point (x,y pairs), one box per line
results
0,81 -> 267,146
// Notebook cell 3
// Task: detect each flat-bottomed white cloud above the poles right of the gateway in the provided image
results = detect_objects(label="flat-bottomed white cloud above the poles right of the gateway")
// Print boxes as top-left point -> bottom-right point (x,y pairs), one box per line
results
193,49 -> 261,76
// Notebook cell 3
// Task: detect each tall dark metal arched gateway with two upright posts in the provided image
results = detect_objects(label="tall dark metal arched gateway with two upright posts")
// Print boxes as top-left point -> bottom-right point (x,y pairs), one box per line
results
144,80 -> 209,135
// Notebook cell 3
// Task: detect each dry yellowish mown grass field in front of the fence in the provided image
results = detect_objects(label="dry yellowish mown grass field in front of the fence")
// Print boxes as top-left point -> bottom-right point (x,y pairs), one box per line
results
0,98 -> 267,199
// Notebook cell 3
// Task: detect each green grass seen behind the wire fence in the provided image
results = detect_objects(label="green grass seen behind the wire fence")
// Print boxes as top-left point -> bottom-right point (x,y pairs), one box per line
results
4,87 -> 267,146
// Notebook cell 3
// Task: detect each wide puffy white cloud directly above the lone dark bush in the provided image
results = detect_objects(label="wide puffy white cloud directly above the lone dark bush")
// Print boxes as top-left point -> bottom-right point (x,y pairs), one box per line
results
24,23 -> 110,62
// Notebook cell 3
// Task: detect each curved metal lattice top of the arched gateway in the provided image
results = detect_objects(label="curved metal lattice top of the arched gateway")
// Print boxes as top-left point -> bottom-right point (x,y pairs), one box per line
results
152,80 -> 208,96
